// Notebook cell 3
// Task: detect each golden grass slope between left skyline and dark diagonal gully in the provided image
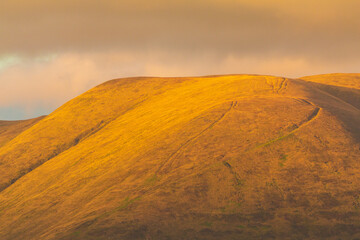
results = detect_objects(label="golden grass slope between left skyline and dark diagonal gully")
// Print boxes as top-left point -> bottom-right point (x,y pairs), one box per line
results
0,78 -> 187,190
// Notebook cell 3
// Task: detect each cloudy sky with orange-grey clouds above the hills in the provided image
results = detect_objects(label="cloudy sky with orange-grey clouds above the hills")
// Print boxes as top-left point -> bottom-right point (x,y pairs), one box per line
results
0,0 -> 360,120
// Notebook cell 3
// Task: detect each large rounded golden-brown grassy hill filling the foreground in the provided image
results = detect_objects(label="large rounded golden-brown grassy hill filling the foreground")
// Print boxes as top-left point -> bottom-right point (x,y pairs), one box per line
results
0,75 -> 360,239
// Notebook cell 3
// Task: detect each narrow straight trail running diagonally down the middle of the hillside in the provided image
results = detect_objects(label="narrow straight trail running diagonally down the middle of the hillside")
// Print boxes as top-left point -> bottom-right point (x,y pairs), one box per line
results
155,101 -> 237,174
